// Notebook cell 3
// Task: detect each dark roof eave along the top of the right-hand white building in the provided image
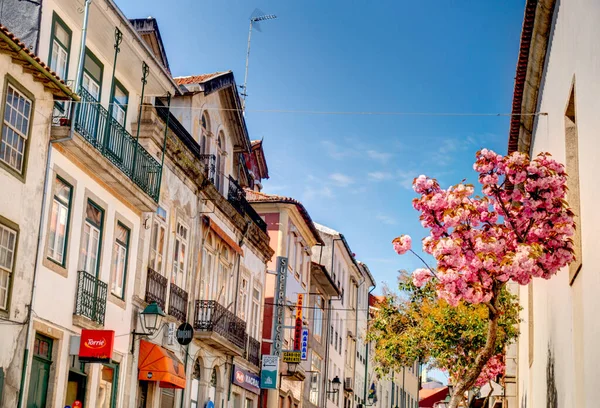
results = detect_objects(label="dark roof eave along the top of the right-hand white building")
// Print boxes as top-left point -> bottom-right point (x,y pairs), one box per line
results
508,0 -> 556,154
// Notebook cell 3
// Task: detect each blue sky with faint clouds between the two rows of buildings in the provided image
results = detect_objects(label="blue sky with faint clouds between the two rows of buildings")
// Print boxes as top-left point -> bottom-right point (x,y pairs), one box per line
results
118,0 -> 524,294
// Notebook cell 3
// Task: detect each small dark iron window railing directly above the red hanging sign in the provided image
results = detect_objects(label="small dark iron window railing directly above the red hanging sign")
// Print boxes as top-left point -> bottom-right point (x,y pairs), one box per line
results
74,271 -> 108,325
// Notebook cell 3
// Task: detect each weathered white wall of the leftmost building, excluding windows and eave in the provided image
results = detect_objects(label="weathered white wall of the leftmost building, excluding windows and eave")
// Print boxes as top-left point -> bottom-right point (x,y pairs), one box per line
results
0,54 -> 54,407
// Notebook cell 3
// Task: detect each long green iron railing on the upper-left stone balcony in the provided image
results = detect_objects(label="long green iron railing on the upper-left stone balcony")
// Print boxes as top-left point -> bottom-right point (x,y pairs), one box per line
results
75,88 -> 162,202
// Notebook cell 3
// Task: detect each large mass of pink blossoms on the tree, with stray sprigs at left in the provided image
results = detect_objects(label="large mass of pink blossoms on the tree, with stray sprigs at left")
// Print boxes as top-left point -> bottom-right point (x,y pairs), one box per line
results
394,149 -> 575,305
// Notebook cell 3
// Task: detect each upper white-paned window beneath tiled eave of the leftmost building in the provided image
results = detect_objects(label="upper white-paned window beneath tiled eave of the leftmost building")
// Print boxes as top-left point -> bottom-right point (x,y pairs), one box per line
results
0,83 -> 32,174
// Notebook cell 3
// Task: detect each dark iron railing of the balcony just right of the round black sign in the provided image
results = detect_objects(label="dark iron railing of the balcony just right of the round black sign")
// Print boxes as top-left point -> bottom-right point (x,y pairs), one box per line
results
194,300 -> 247,349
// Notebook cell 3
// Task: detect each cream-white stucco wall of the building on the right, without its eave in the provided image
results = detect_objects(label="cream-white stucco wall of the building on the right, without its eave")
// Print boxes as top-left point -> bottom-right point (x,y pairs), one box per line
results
517,0 -> 600,407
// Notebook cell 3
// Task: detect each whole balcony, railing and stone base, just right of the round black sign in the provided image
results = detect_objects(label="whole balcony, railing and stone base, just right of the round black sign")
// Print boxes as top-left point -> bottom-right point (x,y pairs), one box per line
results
193,300 -> 247,357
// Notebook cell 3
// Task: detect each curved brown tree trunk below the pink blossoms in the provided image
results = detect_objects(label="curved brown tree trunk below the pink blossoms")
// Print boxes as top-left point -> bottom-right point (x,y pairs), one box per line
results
448,294 -> 500,408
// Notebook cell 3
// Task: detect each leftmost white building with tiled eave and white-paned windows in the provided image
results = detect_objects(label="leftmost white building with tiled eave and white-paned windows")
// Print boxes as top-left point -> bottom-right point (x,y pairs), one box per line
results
0,27 -> 73,407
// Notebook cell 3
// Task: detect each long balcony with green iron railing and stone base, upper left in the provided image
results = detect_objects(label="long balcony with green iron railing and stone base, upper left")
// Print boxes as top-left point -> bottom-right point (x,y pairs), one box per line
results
52,88 -> 162,212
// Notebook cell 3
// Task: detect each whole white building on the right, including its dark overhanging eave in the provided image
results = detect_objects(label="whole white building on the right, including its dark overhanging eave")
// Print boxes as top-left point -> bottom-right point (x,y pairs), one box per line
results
507,0 -> 600,408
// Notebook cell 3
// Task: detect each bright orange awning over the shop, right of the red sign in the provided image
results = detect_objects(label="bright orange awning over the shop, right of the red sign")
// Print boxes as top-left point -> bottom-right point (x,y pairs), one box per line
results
138,340 -> 185,389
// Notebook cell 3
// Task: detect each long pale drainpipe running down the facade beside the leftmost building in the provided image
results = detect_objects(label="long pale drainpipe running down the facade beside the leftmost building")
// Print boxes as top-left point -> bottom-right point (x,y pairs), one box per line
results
17,0 -> 92,408
